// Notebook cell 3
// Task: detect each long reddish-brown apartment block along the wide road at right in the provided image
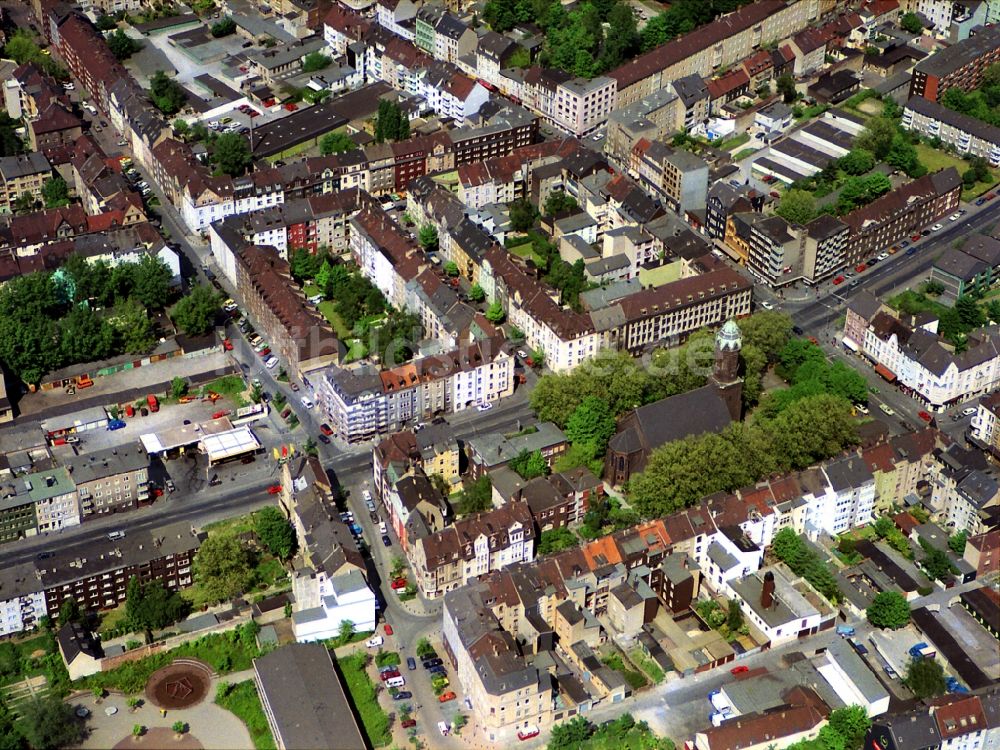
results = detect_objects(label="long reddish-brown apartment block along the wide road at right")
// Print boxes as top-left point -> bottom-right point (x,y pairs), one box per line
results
841,167 -> 962,266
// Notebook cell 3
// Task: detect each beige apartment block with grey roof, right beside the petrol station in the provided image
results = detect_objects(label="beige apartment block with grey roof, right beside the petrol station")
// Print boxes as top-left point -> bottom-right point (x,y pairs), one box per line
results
65,445 -> 149,518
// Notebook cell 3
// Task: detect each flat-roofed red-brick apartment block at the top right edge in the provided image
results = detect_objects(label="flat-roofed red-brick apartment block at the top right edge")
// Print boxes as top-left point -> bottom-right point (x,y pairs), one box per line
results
910,26 -> 1000,102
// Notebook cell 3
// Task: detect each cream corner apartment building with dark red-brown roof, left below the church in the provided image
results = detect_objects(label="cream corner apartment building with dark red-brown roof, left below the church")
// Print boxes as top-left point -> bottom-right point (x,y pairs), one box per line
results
408,503 -> 535,599
